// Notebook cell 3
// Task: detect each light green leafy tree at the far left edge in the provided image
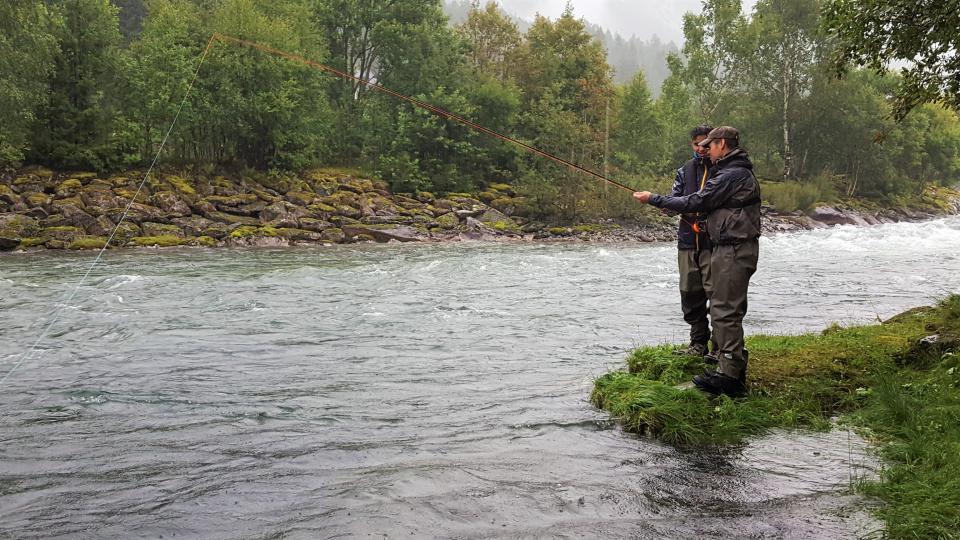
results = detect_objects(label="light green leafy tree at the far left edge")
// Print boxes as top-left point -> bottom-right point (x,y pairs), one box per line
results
0,0 -> 57,166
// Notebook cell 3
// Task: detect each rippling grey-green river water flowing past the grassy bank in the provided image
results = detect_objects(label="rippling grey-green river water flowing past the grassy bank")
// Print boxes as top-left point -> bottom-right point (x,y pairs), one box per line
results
0,217 -> 960,538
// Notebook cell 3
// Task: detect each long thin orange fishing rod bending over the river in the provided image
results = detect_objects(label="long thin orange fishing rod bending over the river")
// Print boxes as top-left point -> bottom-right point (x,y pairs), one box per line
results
208,33 -> 636,193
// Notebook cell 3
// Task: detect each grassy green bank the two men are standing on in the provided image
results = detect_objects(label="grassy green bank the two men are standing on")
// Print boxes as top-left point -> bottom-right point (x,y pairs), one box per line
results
592,295 -> 960,538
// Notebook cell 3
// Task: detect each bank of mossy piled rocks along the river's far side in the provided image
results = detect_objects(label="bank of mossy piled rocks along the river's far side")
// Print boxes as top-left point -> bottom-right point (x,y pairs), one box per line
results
0,168 -> 960,251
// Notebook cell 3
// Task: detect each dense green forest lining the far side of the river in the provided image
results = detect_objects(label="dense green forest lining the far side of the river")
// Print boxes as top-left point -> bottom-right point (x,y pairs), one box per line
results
0,0 -> 960,220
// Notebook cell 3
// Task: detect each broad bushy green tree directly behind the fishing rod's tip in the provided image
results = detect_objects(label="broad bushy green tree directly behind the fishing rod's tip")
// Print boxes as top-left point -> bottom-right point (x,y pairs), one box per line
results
128,0 -> 333,169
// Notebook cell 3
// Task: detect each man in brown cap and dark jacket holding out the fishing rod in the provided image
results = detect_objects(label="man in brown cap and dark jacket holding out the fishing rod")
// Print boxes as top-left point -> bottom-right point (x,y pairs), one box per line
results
633,126 -> 760,396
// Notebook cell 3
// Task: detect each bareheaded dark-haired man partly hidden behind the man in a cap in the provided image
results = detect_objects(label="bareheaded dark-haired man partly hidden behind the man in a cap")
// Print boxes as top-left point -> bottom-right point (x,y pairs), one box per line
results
670,126 -> 716,358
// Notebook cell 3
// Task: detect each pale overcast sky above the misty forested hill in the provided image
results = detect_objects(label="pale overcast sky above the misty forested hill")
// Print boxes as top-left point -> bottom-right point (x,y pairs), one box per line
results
496,0 -> 756,46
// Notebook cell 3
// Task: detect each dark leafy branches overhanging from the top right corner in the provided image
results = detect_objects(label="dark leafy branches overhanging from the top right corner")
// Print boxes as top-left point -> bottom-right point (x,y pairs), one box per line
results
824,0 -> 960,119
